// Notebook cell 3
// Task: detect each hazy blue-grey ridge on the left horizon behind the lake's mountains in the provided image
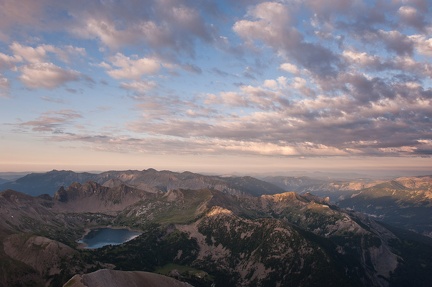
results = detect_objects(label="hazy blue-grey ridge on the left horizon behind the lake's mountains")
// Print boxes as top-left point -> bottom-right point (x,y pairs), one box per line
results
0,169 -> 283,199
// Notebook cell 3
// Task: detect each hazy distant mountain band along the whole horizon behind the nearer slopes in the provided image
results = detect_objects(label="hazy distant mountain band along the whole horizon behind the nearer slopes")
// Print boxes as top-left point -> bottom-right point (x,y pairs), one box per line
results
0,169 -> 432,236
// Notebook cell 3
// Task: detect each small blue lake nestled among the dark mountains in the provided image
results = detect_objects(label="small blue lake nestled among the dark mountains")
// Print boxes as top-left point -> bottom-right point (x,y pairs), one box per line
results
78,227 -> 141,249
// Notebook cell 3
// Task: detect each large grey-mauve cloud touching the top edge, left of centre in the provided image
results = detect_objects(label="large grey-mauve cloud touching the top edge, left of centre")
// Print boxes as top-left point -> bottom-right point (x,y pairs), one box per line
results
71,0 -> 214,54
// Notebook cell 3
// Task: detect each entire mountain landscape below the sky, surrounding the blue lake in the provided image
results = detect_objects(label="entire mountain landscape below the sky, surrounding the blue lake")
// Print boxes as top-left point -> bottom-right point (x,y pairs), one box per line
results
0,169 -> 432,287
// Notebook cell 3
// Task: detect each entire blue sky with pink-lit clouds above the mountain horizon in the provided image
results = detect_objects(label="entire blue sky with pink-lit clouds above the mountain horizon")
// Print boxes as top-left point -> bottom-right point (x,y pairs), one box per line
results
0,0 -> 432,173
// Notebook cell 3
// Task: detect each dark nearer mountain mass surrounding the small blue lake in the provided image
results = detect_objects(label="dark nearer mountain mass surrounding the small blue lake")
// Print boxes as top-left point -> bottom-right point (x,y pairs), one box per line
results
0,174 -> 432,287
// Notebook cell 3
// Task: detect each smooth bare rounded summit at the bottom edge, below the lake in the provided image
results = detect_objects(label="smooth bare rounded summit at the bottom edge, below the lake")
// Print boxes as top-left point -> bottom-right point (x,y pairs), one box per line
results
63,269 -> 192,287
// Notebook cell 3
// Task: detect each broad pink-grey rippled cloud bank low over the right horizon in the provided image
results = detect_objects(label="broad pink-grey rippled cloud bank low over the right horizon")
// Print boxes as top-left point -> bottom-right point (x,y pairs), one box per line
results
120,66 -> 432,156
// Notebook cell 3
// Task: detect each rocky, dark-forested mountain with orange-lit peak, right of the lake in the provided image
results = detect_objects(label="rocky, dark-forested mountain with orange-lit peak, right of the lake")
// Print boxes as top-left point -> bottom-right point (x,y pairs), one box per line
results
178,207 -> 358,286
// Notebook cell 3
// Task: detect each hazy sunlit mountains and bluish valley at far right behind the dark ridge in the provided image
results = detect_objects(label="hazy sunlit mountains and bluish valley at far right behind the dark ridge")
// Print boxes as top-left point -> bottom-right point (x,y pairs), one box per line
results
264,176 -> 432,237
